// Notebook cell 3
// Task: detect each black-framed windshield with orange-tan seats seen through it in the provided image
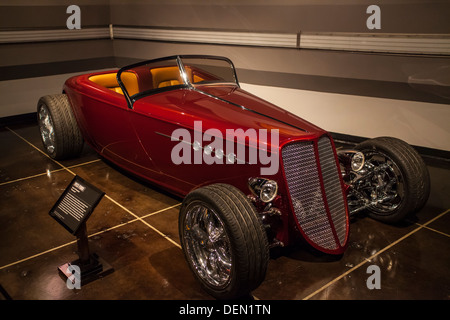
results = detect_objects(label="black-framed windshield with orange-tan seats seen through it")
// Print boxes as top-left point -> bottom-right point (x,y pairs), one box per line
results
118,56 -> 237,105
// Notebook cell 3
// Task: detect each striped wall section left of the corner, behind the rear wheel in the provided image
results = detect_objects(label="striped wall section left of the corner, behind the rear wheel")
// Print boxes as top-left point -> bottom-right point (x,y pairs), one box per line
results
0,0 -> 114,118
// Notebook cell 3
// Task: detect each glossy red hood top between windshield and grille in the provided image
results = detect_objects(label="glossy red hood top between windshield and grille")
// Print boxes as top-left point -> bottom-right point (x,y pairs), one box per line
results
134,85 -> 325,145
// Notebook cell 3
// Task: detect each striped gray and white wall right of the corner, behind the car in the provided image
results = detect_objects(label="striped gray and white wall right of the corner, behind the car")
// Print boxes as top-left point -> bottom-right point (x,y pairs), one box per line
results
111,0 -> 450,150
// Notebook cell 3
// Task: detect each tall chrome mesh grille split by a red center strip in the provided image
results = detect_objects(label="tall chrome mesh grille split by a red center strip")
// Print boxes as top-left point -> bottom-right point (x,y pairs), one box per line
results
282,136 -> 347,250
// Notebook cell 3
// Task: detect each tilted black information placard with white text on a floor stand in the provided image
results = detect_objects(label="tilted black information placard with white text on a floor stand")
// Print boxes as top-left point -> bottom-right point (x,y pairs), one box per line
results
50,176 -> 105,235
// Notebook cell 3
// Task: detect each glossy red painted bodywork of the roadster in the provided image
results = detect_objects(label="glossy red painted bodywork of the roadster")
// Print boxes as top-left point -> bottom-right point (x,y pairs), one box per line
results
63,57 -> 348,254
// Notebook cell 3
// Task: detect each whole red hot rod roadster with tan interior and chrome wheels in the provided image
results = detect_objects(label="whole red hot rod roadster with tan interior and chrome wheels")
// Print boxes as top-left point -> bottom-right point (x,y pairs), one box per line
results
37,55 -> 430,298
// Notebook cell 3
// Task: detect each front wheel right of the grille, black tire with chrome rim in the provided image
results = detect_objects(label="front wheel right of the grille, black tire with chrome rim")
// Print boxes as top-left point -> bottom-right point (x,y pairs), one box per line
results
352,137 -> 430,223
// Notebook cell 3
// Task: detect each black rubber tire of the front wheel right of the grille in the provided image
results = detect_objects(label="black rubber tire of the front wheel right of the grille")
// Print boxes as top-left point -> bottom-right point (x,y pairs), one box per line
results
356,137 -> 430,223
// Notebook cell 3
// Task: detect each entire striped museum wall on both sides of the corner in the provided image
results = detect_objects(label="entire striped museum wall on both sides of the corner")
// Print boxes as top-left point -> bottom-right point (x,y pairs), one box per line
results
0,0 -> 450,151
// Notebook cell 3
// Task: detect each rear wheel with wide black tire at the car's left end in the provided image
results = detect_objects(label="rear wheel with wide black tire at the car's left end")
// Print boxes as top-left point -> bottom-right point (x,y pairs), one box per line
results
37,94 -> 84,160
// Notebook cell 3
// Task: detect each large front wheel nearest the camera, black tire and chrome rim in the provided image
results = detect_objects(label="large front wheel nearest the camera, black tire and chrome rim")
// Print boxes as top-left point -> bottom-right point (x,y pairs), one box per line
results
179,184 -> 269,299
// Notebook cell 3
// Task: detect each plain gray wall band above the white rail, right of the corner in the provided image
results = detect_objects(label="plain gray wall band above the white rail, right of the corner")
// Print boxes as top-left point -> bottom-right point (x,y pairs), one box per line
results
111,0 -> 450,33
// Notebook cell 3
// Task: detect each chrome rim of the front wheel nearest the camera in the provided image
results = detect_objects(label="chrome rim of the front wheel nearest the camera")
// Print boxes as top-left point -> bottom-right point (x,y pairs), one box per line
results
184,201 -> 232,287
